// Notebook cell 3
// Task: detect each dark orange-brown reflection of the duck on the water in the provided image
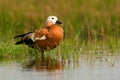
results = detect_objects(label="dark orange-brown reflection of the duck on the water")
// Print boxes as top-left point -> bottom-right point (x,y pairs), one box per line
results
24,57 -> 63,71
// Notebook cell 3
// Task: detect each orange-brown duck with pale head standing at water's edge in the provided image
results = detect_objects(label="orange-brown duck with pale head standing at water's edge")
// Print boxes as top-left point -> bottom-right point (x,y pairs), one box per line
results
14,15 -> 64,53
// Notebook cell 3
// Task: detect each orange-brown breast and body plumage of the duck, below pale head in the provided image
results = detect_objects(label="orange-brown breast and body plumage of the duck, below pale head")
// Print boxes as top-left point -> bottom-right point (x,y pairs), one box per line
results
32,25 -> 64,50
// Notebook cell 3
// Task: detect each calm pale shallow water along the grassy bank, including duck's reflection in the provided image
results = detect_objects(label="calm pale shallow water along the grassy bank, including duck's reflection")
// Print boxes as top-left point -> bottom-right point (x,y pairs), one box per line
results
0,56 -> 120,80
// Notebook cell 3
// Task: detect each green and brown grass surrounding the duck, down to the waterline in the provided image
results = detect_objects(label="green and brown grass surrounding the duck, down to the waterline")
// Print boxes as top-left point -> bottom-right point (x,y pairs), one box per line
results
0,0 -> 120,59
